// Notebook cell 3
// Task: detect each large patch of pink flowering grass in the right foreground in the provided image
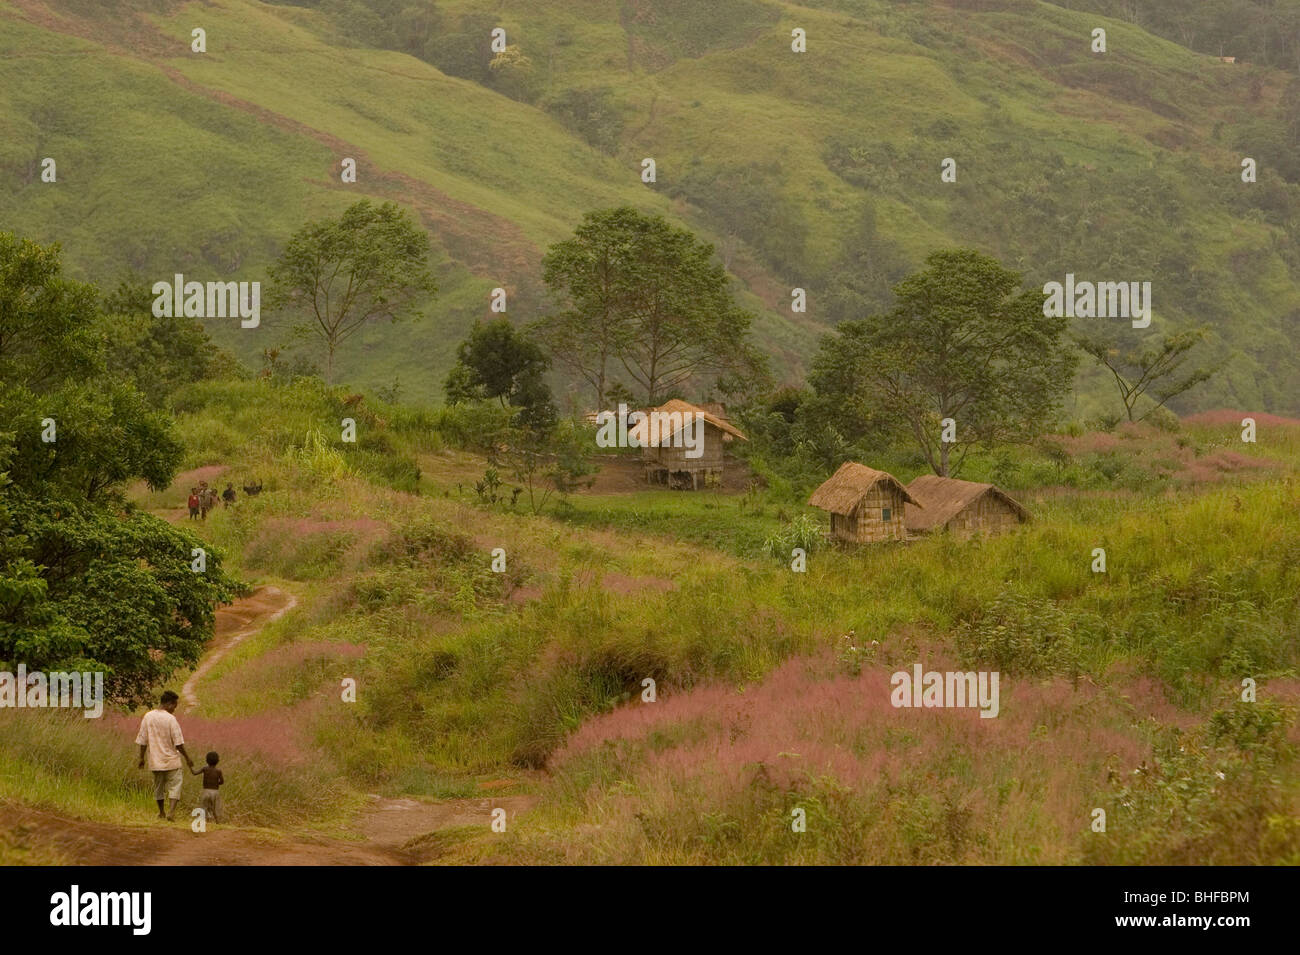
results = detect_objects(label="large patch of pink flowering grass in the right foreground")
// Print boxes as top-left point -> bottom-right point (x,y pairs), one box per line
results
533,652 -> 1222,864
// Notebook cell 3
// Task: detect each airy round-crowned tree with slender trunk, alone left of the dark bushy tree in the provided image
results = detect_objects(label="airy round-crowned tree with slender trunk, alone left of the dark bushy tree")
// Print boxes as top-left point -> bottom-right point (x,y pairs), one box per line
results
267,199 -> 437,382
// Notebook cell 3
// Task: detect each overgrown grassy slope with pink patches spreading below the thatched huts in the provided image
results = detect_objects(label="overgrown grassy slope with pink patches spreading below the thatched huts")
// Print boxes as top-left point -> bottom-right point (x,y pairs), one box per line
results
0,382 -> 1300,863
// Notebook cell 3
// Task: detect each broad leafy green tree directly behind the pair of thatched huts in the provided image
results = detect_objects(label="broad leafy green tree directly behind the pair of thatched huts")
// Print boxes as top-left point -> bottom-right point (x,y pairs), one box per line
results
811,249 -> 1076,476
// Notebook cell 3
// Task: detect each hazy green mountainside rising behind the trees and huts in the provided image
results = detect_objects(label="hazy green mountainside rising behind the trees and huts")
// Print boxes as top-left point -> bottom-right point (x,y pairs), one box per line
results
0,0 -> 1300,413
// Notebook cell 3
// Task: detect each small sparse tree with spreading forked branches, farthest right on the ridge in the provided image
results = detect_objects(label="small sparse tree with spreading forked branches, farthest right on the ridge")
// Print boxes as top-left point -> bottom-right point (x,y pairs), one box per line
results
1075,329 -> 1217,421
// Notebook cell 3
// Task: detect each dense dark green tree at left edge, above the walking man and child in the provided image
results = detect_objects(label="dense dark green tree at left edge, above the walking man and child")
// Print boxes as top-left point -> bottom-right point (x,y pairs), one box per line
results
0,235 -> 239,703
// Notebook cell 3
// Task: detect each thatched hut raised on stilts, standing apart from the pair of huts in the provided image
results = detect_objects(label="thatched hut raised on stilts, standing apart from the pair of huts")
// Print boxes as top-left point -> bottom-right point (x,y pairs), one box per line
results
628,398 -> 749,490
